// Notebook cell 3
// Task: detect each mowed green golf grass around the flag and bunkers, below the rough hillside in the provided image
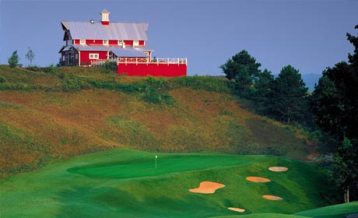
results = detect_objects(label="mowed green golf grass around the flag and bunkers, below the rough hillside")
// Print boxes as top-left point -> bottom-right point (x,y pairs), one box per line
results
0,149 -> 328,217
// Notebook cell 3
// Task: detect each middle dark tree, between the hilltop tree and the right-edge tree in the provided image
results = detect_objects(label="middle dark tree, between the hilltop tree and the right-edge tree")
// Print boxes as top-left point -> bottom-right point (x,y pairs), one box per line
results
266,65 -> 308,123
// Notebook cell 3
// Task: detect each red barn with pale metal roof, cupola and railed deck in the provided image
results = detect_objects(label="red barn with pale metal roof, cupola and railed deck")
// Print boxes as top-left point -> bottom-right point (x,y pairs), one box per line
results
59,10 -> 187,77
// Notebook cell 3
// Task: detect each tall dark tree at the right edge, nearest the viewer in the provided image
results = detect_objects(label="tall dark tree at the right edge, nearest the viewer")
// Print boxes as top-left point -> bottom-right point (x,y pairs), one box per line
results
311,25 -> 358,201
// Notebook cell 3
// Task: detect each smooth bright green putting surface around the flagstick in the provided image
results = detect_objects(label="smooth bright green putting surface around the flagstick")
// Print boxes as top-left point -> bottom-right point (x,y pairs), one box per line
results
68,154 -> 262,179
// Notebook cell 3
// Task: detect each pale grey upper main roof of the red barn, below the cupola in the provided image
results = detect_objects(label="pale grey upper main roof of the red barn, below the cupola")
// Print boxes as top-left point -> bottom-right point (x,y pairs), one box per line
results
61,21 -> 148,40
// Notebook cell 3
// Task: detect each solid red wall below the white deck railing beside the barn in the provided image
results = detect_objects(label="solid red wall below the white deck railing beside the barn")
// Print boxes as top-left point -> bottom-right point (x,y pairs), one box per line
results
117,63 -> 187,77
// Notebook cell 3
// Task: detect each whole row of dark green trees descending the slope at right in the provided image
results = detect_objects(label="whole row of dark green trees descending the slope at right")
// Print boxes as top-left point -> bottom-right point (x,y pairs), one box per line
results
221,25 -> 358,202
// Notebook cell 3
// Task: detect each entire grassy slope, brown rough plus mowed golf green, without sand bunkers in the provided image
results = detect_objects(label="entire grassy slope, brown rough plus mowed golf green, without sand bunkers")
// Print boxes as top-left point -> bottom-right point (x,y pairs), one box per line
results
0,66 -> 358,218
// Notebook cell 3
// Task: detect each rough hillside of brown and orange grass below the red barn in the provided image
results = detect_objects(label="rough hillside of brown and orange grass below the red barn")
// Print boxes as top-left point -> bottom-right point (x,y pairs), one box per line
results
0,66 -> 314,177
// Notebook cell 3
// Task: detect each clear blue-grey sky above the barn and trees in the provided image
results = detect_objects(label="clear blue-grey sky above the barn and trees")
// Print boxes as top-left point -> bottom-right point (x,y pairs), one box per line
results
0,0 -> 358,75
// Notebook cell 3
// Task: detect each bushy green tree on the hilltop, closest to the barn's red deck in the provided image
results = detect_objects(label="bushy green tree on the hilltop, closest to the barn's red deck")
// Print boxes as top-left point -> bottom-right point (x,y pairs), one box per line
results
220,50 -> 261,91
